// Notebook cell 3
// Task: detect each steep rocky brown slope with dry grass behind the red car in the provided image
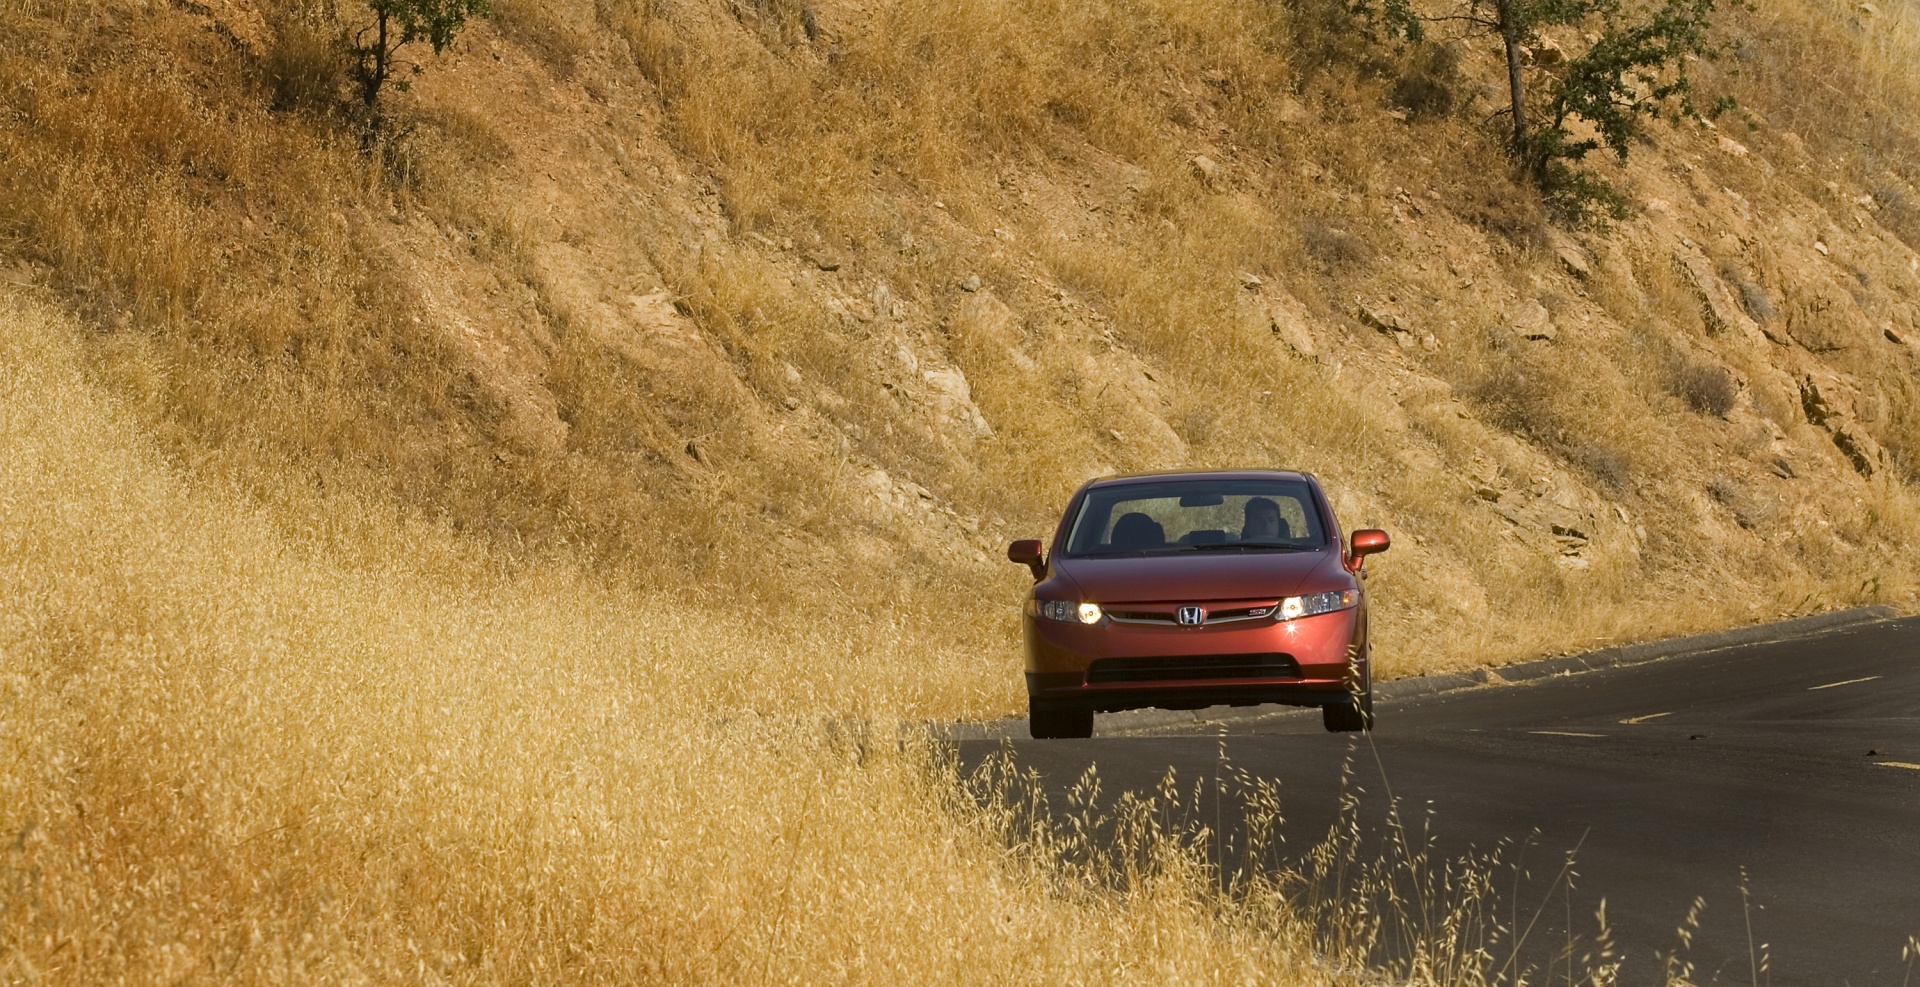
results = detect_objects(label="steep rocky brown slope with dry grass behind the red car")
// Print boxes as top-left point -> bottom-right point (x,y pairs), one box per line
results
0,0 -> 1920,698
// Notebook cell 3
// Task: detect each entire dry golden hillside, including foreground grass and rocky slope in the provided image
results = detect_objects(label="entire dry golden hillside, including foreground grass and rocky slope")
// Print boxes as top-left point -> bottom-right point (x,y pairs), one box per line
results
0,0 -> 1920,983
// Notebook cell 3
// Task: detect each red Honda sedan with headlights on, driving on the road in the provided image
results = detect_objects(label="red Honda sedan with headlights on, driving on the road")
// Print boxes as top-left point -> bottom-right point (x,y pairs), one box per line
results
1006,470 -> 1388,737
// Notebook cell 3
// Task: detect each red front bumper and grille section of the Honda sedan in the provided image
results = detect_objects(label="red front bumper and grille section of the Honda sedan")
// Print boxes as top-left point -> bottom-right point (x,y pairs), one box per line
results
1025,605 -> 1371,712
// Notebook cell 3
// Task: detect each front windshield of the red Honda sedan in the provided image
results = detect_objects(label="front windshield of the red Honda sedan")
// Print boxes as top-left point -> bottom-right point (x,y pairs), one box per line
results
1068,478 -> 1327,557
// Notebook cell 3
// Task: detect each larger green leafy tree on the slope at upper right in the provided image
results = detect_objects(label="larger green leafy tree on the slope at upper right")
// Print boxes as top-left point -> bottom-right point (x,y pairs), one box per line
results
1356,0 -> 1745,214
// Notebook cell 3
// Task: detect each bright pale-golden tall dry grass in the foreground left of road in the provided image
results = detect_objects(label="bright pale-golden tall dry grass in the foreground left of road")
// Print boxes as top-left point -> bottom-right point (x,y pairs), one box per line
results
0,288 -> 1308,983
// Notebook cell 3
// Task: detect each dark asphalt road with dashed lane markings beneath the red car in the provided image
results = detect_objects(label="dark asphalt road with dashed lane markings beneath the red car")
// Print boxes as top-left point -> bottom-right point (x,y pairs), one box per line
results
958,618 -> 1920,985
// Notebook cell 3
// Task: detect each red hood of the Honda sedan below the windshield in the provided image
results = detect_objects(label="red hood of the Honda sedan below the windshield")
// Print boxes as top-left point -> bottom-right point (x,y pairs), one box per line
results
1054,549 -> 1354,605
